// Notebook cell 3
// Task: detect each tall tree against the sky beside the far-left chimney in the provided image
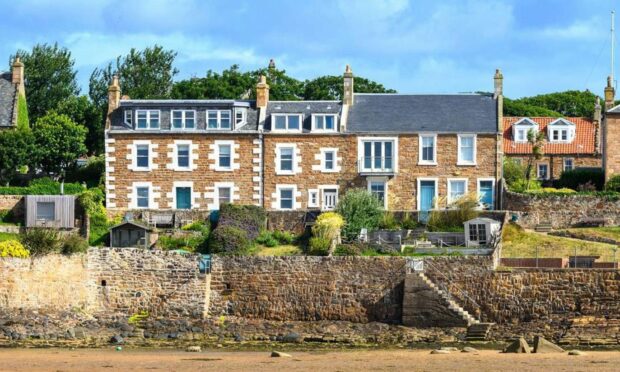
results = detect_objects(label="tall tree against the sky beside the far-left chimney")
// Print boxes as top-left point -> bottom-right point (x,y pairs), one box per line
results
10,44 -> 80,122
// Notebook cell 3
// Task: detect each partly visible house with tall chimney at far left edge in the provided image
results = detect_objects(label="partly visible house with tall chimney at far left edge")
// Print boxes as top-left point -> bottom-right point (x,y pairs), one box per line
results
0,58 -> 26,129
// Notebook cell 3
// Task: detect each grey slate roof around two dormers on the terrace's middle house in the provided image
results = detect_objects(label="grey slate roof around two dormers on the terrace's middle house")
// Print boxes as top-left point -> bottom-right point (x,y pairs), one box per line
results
264,101 -> 342,133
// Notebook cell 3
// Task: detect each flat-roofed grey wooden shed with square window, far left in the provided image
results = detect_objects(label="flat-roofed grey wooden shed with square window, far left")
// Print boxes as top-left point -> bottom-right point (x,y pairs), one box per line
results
26,195 -> 75,229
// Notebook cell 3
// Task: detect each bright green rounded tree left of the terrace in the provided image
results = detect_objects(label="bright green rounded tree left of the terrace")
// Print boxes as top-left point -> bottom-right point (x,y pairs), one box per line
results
32,112 -> 87,179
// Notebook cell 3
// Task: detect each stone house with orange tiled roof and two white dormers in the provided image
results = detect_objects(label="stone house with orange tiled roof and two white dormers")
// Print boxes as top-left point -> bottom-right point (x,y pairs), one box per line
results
504,104 -> 602,180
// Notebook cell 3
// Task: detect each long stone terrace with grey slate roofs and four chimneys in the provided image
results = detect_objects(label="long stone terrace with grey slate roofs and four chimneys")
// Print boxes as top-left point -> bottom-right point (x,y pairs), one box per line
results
106,67 -> 502,213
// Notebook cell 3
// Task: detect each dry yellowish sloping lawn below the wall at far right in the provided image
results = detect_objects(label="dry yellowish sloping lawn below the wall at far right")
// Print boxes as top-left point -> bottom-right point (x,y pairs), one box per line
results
502,224 -> 620,262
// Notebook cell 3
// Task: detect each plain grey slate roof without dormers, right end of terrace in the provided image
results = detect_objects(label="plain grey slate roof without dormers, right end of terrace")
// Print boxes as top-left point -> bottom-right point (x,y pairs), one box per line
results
347,93 -> 497,133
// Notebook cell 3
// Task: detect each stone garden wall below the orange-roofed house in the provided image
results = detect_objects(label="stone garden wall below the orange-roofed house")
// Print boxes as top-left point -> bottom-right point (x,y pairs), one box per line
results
504,190 -> 620,229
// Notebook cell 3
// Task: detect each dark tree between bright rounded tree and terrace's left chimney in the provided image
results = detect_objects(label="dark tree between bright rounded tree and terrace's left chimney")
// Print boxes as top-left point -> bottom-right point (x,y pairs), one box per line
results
56,96 -> 104,155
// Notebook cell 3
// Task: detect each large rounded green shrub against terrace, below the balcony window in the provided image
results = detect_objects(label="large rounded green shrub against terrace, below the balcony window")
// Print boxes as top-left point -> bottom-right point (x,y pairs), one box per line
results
336,189 -> 383,239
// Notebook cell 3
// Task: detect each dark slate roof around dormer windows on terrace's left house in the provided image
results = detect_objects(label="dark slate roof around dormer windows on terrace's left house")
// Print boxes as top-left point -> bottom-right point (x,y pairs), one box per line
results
110,99 -> 258,133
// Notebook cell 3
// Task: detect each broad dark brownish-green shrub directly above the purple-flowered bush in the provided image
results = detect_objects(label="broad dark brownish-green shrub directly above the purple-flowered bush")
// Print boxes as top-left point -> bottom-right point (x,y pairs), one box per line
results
218,203 -> 267,240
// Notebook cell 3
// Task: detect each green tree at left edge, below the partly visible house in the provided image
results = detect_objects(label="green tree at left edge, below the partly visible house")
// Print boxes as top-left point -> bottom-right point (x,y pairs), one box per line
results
0,130 -> 36,185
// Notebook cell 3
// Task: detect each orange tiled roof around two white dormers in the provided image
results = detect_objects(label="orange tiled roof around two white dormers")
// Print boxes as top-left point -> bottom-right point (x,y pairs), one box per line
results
504,117 -> 596,155
